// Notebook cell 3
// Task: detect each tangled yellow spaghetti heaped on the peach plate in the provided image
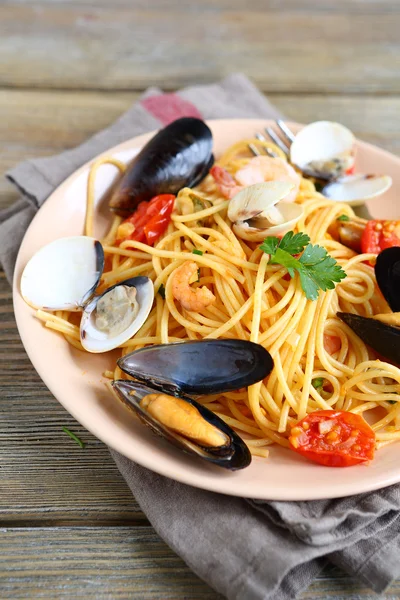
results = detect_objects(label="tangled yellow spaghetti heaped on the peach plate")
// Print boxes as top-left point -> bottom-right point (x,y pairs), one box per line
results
37,140 -> 400,457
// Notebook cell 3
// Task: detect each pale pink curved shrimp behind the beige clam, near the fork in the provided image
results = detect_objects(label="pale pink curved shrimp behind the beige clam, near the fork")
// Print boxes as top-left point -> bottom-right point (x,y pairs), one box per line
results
210,156 -> 300,202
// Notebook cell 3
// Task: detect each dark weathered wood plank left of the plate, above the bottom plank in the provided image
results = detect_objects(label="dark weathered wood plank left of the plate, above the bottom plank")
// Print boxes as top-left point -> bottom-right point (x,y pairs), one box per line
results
0,273 -> 145,524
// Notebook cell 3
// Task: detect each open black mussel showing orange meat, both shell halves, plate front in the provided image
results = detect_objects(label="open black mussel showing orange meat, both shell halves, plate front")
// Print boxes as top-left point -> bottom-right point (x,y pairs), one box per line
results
112,339 -> 273,470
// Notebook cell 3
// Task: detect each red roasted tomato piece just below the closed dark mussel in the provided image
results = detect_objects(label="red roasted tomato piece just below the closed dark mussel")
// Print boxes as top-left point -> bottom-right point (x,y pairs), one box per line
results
117,194 -> 175,246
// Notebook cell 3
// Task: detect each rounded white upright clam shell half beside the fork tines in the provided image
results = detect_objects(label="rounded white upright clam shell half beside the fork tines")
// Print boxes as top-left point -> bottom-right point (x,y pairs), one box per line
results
290,121 -> 355,177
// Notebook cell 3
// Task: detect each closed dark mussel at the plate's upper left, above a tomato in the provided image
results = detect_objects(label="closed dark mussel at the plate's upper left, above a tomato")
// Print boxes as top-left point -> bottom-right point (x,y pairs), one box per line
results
110,117 -> 214,216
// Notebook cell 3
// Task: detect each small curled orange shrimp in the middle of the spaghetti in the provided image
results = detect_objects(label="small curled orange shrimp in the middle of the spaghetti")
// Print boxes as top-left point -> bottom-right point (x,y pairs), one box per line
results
172,260 -> 216,312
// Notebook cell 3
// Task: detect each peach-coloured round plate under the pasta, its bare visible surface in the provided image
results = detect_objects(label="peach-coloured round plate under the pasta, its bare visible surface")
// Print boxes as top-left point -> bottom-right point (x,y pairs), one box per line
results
14,119 -> 400,500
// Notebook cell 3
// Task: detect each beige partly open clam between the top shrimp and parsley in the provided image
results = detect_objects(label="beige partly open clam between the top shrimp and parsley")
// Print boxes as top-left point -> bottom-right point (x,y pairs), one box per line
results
228,181 -> 304,242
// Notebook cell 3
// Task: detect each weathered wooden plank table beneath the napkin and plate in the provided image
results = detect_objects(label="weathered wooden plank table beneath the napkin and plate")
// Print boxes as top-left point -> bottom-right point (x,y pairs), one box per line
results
0,0 -> 400,600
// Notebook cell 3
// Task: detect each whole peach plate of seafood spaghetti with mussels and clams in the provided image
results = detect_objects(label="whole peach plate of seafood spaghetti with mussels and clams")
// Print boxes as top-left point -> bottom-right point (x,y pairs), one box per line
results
13,119 -> 400,500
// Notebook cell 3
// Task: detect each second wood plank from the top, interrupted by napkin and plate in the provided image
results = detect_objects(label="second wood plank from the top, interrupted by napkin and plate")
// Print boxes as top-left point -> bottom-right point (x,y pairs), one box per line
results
0,89 -> 400,212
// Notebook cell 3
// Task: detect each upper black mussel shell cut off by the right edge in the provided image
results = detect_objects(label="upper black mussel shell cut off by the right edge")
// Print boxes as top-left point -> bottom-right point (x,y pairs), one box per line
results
375,246 -> 400,312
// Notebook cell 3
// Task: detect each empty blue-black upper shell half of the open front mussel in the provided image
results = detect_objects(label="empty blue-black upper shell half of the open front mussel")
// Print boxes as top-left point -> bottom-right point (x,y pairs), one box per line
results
118,339 -> 274,395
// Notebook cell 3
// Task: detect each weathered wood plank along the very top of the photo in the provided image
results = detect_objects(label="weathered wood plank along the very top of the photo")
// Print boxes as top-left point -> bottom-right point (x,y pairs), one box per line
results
0,0 -> 400,94
